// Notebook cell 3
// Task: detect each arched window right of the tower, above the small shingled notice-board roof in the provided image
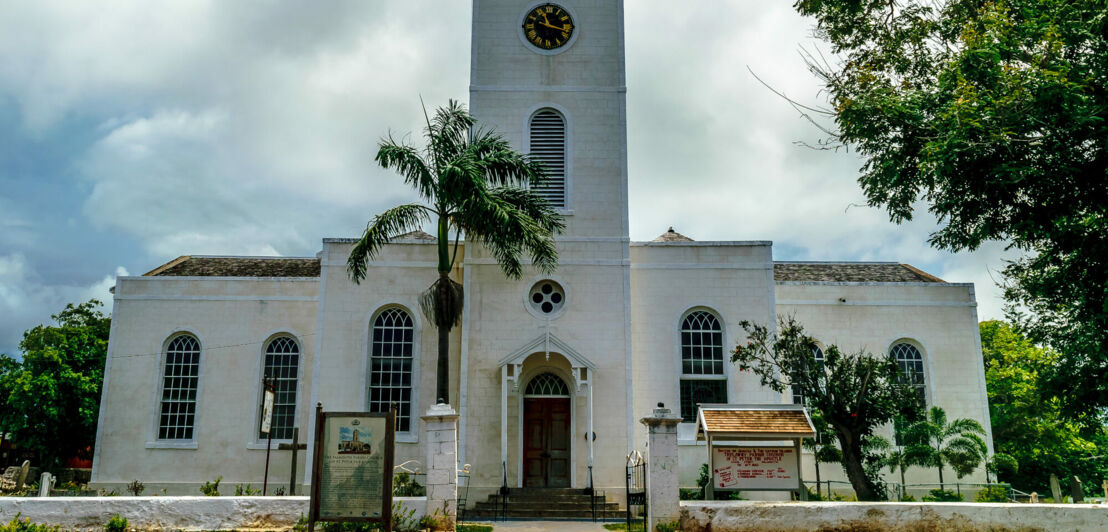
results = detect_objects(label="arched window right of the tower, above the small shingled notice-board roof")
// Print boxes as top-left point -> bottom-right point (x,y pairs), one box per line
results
680,310 -> 727,421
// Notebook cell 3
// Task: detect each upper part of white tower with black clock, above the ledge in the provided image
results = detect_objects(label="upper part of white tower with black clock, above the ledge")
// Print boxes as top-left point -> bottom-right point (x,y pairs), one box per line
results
470,0 -> 628,242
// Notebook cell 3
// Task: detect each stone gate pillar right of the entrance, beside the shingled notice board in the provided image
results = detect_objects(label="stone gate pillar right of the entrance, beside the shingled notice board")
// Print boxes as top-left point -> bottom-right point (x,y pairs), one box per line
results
639,402 -> 681,530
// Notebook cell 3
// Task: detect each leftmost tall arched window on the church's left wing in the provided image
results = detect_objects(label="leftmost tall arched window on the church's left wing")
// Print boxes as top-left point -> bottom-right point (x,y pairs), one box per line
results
157,335 -> 201,440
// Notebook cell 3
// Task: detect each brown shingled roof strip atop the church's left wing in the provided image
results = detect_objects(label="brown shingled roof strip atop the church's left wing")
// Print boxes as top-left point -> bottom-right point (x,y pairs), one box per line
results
145,255 -> 319,277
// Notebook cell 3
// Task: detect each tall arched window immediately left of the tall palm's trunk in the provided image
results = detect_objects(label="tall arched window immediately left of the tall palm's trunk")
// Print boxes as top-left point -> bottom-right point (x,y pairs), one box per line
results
369,307 -> 416,432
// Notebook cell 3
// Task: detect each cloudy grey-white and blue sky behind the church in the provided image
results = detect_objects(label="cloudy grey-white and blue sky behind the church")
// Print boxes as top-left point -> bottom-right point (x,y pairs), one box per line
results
0,0 -> 1005,354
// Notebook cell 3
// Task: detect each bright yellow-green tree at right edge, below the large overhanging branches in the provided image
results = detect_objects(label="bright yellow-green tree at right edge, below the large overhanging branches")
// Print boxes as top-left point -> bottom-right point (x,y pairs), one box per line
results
979,321 -> 1108,493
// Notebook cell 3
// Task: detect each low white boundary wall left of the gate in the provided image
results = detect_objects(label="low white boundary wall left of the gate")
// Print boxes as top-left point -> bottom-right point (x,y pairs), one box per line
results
0,497 -> 427,531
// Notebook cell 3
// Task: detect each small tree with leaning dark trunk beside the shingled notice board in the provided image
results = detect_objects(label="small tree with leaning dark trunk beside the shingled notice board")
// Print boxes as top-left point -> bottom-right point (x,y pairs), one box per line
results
731,316 -> 915,501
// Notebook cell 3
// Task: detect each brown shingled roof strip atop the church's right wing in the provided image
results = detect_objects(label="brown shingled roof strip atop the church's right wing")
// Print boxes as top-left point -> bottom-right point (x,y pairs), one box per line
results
773,263 -> 946,283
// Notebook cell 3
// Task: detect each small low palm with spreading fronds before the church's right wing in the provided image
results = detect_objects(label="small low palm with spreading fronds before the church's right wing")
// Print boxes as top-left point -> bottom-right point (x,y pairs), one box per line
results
904,407 -> 988,489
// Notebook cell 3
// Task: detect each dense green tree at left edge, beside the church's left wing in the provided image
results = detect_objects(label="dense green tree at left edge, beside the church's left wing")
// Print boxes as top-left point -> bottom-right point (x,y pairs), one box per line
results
0,299 -> 111,470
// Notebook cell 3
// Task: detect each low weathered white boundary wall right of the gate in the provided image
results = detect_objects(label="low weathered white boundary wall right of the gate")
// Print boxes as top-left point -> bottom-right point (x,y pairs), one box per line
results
680,501 -> 1108,532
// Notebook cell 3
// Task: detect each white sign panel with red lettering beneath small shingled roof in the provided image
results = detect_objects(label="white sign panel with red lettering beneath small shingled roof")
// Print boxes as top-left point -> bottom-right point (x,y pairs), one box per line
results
711,446 -> 800,491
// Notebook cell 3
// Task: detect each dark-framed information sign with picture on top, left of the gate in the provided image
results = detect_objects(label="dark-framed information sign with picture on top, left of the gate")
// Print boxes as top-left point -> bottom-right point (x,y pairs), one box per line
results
308,405 -> 396,531
